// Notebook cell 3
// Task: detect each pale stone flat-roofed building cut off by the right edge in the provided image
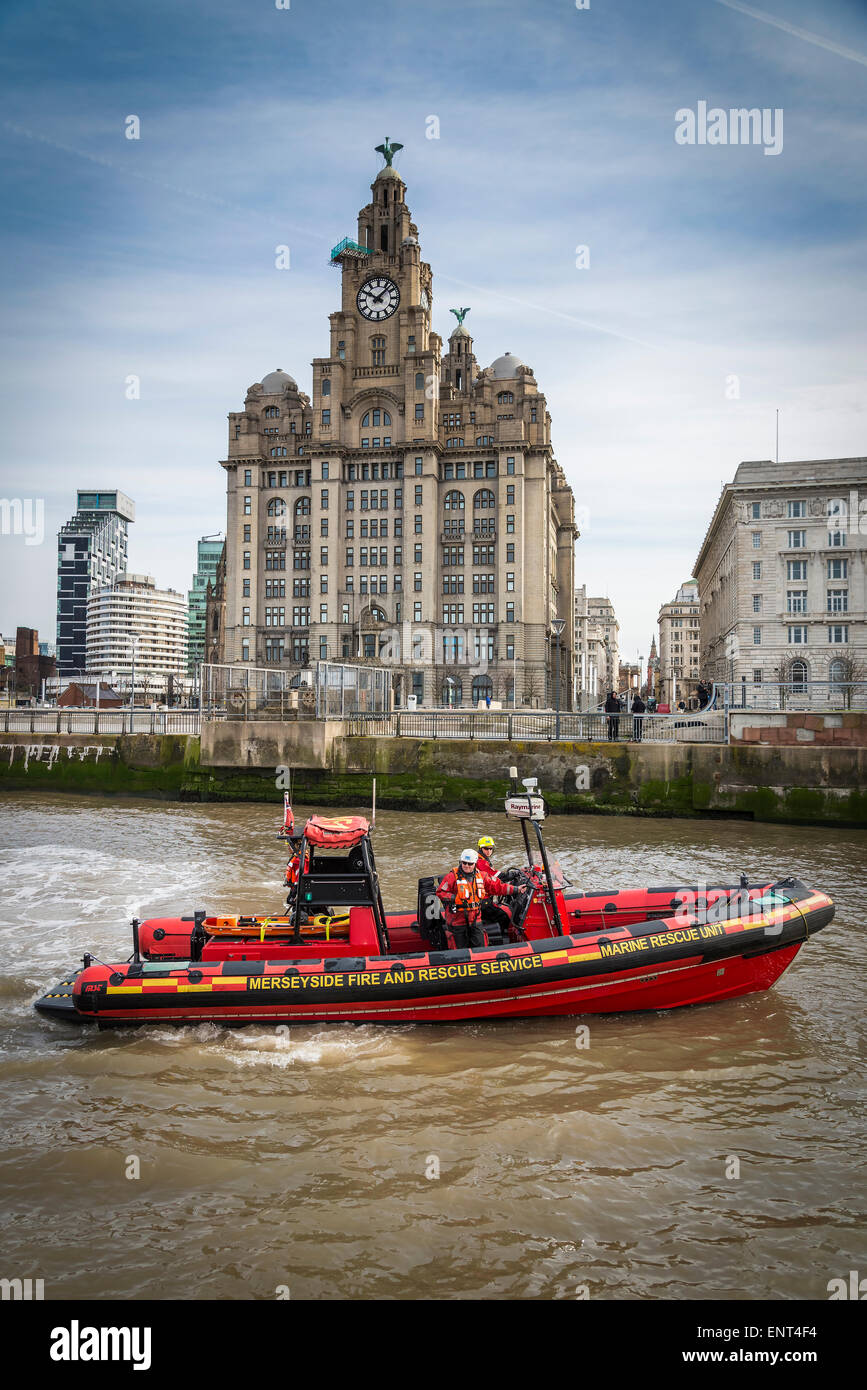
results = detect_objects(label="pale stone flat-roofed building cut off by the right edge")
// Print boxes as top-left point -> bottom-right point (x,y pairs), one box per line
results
696,457 -> 867,685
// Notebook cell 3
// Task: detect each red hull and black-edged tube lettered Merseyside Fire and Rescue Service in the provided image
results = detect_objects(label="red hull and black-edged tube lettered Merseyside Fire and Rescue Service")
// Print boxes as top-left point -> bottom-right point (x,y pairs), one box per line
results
36,880 -> 834,1026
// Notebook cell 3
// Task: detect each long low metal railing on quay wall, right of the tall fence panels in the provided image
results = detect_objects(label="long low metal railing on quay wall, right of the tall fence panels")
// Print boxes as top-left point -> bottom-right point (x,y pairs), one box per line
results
347,710 -> 727,744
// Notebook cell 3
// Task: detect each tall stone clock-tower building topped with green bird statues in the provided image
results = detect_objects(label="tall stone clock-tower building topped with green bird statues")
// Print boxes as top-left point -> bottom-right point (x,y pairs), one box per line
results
215,140 -> 577,708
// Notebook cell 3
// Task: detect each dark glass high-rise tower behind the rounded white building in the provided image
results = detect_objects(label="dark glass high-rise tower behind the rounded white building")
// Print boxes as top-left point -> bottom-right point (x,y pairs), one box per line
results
57,492 -> 135,676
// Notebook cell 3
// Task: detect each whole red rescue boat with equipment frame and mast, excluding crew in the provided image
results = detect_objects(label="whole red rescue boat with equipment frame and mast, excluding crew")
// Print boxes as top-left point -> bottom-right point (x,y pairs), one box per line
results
35,783 -> 834,1026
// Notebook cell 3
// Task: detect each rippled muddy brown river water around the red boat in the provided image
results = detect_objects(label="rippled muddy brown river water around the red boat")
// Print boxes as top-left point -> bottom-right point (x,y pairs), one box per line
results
0,794 -> 867,1300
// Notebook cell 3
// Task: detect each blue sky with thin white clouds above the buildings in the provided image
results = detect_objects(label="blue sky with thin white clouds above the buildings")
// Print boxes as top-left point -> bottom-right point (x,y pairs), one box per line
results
0,0 -> 867,657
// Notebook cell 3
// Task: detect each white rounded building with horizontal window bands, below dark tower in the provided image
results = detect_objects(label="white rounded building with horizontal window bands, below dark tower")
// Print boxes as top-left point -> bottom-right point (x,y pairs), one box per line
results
86,574 -> 188,699
